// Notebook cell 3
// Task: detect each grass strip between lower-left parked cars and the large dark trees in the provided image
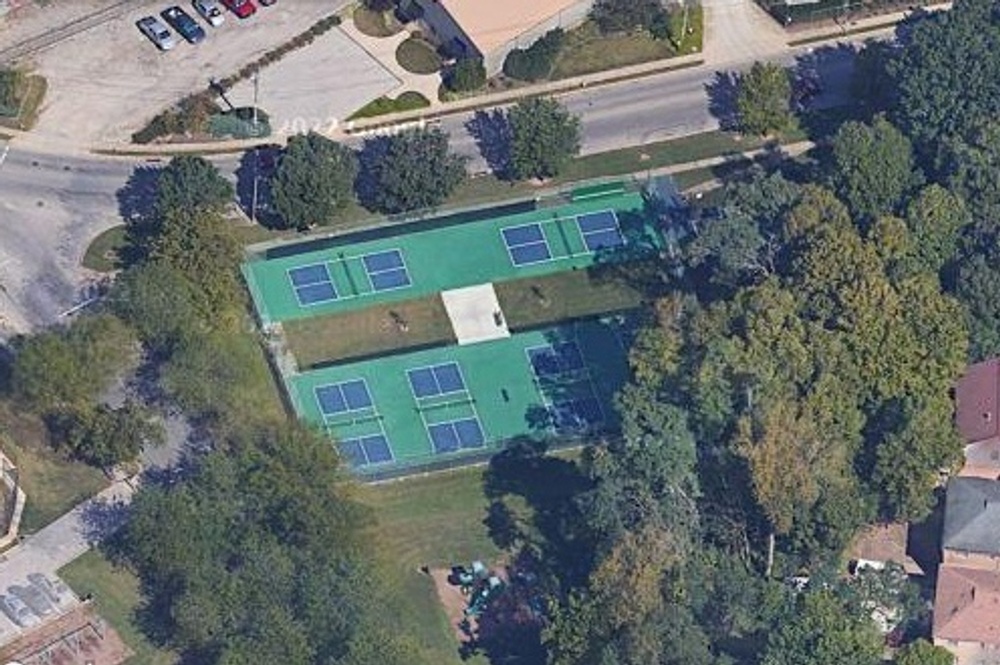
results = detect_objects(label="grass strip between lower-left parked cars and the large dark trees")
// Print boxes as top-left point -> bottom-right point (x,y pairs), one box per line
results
59,550 -> 179,665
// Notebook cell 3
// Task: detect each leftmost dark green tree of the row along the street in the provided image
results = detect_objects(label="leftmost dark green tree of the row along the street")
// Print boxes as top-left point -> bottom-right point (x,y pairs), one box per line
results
155,155 -> 234,223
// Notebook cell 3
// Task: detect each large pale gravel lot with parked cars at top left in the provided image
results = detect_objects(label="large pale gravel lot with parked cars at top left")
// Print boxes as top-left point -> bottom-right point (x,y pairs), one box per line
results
25,0 -> 352,145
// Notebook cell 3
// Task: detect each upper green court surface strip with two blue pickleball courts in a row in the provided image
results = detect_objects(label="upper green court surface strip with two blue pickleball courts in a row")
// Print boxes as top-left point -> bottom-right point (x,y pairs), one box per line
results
243,187 -> 661,325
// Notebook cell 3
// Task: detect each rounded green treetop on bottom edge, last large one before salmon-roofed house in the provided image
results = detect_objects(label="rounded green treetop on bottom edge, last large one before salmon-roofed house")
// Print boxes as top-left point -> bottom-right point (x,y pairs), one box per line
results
761,590 -> 882,665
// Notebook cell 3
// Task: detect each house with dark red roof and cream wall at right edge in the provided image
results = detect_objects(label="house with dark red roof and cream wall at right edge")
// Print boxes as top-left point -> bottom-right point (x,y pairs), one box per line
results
955,358 -> 1000,480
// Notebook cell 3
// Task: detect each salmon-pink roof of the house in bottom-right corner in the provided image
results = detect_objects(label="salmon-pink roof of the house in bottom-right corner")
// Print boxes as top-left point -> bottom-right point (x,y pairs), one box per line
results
933,565 -> 1000,645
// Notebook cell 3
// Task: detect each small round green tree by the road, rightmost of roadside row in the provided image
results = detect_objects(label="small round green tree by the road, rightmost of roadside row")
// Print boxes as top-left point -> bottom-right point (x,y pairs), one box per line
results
736,62 -> 792,136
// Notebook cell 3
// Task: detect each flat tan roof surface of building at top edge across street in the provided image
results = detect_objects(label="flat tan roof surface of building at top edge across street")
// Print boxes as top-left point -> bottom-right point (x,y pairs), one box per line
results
440,0 -> 580,55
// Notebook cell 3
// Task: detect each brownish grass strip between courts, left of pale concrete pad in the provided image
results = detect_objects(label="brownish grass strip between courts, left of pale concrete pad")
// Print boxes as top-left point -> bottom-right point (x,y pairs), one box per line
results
282,294 -> 455,369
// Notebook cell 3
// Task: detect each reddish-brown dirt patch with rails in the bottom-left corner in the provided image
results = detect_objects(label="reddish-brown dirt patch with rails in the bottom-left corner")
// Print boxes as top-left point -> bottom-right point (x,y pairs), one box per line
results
0,604 -> 133,665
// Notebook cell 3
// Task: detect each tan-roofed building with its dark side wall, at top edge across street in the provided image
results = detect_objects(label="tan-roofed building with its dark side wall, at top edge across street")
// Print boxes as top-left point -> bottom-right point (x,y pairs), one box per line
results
414,0 -> 593,75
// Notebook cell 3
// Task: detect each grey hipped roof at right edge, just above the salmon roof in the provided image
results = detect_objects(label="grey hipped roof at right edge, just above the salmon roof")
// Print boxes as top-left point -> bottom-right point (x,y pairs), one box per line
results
941,478 -> 1000,554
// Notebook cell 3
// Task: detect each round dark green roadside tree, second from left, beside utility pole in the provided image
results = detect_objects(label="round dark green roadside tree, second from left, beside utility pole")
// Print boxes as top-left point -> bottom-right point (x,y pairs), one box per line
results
272,132 -> 358,229
